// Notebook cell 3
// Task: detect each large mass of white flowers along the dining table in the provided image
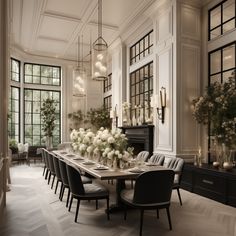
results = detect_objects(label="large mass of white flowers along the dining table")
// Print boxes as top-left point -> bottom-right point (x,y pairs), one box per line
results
70,127 -> 133,168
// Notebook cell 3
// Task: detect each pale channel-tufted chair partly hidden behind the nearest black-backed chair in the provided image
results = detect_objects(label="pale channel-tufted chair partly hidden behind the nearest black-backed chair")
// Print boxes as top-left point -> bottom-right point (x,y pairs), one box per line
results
164,157 -> 184,206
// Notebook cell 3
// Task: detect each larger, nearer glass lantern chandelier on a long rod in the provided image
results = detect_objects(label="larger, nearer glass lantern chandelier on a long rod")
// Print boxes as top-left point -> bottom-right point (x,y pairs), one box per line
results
92,0 -> 108,81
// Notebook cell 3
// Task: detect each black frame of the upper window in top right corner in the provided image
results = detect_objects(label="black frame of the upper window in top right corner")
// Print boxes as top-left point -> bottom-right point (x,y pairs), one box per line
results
208,0 -> 236,41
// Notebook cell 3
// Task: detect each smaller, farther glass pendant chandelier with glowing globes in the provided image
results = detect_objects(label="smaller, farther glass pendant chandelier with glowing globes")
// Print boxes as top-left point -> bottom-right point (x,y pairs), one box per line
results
73,36 -> 86,97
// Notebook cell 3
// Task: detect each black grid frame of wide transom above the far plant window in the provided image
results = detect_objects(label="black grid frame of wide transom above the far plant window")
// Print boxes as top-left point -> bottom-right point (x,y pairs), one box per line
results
23,62 -> 61,87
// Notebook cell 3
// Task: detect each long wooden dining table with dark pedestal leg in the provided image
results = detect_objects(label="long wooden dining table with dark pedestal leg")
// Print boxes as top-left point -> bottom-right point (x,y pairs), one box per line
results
52,150 -> 166,212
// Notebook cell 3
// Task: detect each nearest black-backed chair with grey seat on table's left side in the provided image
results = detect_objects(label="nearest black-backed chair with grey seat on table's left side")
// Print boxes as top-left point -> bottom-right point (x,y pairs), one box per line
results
66,164 -> 110,222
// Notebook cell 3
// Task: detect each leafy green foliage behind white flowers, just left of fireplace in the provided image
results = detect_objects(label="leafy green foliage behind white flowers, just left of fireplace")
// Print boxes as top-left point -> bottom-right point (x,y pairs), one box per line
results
87,107 -> 111,130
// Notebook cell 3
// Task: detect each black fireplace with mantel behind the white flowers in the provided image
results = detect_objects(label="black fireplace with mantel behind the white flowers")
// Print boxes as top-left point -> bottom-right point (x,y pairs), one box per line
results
120,125 -> 154,156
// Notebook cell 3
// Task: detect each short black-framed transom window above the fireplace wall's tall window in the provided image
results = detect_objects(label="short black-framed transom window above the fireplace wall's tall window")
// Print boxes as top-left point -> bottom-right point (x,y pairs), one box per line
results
130,30 -> 153,65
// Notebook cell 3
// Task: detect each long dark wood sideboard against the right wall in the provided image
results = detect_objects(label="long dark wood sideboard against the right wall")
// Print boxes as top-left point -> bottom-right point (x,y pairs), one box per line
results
181,163 -> 236,207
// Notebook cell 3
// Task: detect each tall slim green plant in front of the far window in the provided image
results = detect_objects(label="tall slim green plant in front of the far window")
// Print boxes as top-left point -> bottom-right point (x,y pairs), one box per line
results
41,98 -> 56,137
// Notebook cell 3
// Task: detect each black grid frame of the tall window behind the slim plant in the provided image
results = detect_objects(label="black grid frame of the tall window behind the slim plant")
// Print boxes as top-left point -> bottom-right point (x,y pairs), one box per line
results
23,88 -> 61,146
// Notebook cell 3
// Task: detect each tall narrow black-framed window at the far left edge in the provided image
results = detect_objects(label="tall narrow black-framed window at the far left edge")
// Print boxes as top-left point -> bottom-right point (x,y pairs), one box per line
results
8,86 -> 20,142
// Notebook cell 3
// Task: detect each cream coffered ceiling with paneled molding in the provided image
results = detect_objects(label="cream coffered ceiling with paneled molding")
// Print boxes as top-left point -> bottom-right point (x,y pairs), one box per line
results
11,0 -> 154,60
